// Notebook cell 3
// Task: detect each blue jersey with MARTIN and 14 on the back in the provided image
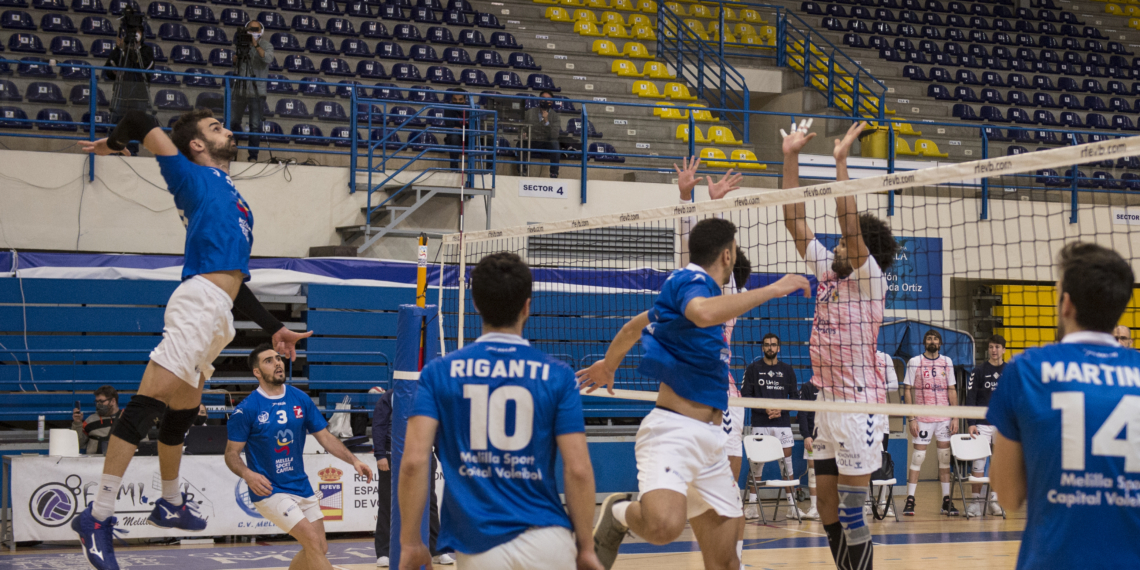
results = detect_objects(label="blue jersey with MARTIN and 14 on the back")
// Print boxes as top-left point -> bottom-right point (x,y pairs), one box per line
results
986,332 -> 1140,570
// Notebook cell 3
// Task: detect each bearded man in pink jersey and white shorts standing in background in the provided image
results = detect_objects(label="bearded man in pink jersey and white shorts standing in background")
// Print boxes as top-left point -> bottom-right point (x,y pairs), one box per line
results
903,328 -> 959,516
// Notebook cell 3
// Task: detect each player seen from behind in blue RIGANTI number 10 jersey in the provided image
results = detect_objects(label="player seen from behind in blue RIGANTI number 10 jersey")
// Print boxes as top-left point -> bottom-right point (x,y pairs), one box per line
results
399,253 -> 602,570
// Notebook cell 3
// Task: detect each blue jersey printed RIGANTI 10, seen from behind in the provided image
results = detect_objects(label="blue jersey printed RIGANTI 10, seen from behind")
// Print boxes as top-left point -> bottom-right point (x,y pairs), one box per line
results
412,333 -> 586,554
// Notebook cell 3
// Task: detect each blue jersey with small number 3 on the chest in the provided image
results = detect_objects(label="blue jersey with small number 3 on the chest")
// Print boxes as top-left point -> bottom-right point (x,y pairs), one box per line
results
226,386 -> 328,503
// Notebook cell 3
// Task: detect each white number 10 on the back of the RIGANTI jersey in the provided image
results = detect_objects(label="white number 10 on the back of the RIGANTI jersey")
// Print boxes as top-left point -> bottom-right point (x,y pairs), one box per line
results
463,384 -> 535,451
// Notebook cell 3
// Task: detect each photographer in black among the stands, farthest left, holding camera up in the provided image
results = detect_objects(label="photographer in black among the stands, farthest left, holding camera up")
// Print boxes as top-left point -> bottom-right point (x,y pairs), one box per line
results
103,8 -> 154,155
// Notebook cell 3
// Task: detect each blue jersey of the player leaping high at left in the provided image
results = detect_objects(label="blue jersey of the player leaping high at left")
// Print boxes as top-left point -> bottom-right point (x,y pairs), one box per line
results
157,153 -> 253,280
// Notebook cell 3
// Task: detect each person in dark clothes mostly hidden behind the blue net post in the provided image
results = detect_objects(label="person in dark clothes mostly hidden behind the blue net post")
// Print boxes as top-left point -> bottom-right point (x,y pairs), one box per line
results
372,390 -> 455,568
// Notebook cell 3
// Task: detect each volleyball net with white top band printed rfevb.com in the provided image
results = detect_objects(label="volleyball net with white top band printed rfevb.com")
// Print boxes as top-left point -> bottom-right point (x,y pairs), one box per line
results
440,138 -> 1140,418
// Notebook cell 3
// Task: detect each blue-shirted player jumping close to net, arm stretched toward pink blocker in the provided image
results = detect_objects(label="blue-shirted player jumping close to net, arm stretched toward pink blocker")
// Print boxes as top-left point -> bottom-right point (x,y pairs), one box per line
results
578,218 -> 811,570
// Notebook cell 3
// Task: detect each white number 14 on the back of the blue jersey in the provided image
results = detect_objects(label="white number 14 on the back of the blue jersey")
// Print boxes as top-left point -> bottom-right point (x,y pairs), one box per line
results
1052,392 -> 1140,473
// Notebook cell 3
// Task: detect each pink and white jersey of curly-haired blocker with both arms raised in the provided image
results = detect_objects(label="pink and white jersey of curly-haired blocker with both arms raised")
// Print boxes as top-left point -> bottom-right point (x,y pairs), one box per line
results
804,239 -> 887,404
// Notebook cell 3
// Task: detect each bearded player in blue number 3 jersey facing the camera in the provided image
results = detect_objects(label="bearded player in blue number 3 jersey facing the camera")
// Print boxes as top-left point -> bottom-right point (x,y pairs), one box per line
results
226,344 -> 372,570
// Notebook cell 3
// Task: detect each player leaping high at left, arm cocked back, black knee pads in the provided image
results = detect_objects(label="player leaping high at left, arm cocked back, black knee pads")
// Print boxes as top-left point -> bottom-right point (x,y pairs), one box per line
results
72,109 -> 312,570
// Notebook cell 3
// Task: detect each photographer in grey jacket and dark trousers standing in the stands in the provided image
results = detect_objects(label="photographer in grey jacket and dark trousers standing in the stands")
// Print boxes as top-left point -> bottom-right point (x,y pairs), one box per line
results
229,19 -> 274,162
